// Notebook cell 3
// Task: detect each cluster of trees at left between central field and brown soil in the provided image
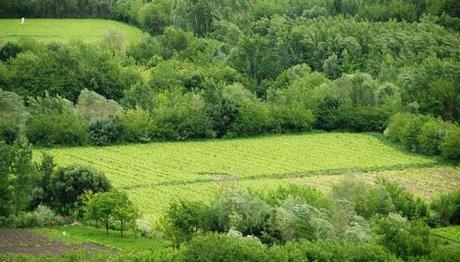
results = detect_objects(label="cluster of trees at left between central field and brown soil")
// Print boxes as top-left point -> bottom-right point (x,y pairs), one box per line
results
0,140 -> 140,236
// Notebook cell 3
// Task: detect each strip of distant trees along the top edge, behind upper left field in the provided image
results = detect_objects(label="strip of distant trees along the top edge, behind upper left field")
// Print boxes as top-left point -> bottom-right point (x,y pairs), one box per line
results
0,0 -> 460,33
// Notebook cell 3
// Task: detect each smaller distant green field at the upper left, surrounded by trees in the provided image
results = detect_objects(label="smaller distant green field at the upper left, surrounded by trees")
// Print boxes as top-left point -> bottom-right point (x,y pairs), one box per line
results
0,18 -> 142,45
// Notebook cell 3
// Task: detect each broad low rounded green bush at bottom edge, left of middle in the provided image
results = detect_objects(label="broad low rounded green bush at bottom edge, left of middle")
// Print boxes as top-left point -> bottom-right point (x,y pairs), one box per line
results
179,234 -> 279,262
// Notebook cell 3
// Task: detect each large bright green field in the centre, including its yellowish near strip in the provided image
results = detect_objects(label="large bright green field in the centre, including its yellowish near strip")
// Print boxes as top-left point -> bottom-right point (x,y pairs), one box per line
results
42,133 -> 460,221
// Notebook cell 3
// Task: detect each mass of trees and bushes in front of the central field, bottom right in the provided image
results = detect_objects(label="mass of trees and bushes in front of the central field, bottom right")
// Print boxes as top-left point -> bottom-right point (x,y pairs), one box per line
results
156,179 -> 460,261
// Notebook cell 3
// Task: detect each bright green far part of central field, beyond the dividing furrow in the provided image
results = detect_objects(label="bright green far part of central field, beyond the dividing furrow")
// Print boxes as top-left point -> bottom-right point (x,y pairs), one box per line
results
45,133 -> 435,188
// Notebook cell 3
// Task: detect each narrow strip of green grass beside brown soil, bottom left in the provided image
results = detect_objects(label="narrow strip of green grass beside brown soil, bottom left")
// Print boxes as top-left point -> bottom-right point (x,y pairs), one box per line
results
34,226 -> 168,252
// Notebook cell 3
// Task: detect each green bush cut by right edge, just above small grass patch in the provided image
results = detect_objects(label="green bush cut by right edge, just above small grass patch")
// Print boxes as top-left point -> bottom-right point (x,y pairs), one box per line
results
431,190 -> 460,226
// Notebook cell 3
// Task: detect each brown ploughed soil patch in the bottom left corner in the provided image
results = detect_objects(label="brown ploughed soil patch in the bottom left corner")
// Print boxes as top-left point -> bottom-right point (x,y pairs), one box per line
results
0,228 -> 108,255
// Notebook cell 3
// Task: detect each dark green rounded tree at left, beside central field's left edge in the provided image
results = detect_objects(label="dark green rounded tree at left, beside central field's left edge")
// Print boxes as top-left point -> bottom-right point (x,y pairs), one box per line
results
45,165 -> 111,215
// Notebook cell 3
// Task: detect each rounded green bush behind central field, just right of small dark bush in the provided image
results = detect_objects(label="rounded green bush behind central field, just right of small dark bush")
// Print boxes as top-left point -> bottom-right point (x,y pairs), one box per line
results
120,108 -> 153,143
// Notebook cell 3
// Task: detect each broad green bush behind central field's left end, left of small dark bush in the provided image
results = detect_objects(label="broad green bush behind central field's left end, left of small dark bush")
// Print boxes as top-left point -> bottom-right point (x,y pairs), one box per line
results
27,113 -> 87,146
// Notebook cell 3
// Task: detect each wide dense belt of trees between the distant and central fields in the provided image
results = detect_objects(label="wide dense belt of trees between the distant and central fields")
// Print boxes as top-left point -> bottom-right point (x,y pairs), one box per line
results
0,4 -> 460,160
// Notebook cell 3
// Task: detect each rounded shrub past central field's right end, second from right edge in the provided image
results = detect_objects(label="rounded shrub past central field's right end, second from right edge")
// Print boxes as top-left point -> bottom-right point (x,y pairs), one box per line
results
417,117 -> 446,155
